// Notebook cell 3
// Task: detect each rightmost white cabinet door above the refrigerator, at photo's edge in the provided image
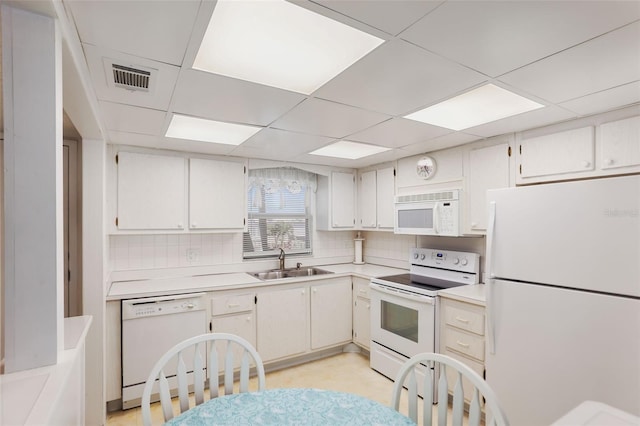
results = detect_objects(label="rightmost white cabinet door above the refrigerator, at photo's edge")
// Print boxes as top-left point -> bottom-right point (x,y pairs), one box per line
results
600,116 -> 640,172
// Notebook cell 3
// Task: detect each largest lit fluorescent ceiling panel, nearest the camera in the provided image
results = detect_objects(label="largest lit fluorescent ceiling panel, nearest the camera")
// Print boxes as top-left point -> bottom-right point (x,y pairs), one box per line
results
193,0 -> 384,95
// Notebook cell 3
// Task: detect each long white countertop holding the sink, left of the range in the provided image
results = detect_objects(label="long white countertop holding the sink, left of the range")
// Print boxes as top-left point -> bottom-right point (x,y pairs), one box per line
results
107,263 -> 407,300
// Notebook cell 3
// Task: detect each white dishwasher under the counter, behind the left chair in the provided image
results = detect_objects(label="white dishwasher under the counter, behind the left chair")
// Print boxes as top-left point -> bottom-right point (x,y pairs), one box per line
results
122,293 -> 207,409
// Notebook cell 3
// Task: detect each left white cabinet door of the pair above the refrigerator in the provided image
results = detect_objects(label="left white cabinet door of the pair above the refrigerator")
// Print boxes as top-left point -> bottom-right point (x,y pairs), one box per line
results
518,126 -> 595,183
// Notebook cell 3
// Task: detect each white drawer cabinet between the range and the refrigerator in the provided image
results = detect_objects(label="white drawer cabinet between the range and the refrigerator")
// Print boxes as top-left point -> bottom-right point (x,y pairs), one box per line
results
440,297 -> 485,402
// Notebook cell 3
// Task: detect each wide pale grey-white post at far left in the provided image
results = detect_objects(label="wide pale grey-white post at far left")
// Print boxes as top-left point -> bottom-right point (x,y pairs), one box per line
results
2,5 -> 64,372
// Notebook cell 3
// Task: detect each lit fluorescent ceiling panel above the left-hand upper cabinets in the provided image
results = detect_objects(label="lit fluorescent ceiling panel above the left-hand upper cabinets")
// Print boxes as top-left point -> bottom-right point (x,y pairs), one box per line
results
165,114 -> 262,145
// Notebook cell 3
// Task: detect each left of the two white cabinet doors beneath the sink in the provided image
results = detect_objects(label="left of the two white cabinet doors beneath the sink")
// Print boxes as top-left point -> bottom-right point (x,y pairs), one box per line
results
257,287 -> 309,362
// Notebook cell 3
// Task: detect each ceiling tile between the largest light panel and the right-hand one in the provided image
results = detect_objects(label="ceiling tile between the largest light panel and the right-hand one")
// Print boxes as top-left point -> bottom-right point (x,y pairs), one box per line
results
314,40 -> 486,115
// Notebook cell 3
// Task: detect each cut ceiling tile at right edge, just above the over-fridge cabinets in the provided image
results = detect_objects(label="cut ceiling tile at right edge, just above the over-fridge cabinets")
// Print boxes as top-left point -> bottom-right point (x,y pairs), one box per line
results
560,81 -> 640,115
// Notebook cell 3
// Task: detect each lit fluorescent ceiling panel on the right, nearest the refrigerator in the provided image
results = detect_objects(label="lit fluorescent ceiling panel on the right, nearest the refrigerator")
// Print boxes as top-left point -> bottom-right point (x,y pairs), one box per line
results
405,84 -> 544,130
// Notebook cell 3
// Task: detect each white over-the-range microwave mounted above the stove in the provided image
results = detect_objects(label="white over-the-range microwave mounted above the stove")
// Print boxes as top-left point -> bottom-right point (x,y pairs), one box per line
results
394,189 -> 460,237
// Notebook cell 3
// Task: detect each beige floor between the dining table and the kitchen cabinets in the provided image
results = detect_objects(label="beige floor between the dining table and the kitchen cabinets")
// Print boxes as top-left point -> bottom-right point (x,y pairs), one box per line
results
107,353 -> 430,426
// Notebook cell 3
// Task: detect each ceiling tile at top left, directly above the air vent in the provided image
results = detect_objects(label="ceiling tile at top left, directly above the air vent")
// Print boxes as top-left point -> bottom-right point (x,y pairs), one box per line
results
65,0 -> 200,65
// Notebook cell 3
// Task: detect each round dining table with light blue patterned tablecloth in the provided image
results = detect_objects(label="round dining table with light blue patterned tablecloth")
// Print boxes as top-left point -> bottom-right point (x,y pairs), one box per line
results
166,388 -> 415,426
